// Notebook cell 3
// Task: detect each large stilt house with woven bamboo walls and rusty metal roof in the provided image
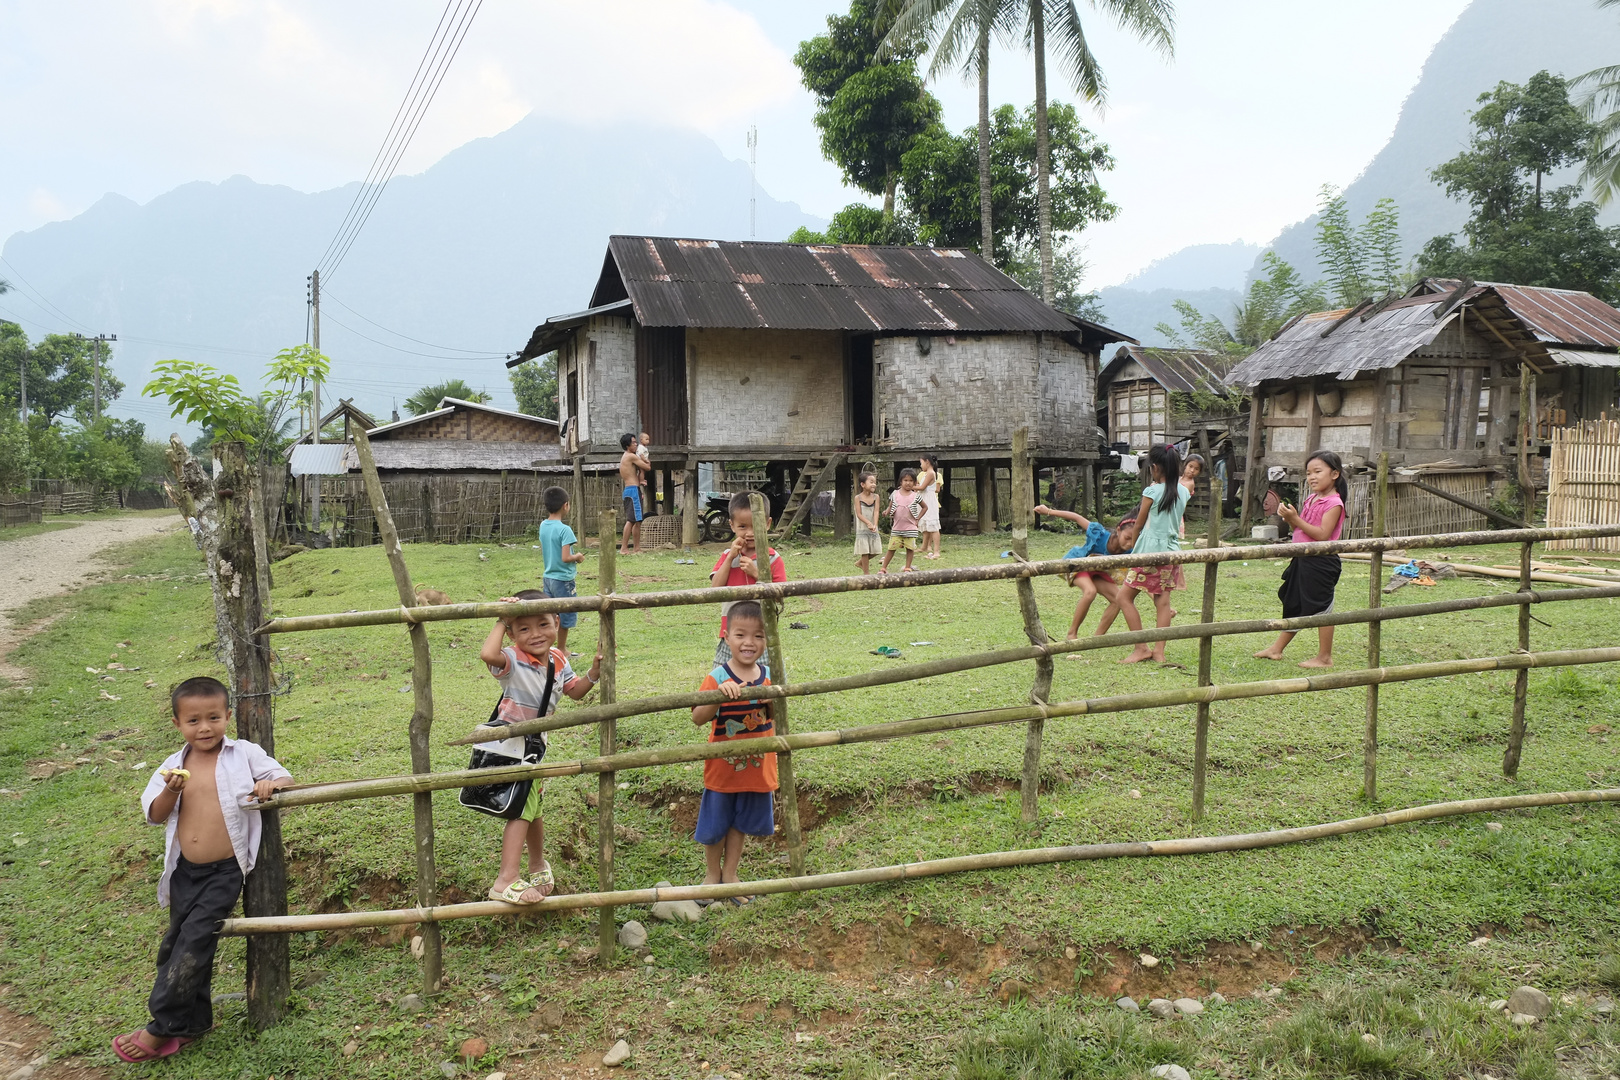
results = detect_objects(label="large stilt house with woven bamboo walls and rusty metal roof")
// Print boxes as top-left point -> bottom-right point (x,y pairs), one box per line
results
512,236 -> 1129,538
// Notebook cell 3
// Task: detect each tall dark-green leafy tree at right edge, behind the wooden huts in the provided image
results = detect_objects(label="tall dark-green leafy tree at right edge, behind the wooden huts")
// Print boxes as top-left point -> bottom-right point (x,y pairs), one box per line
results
1419,71 -> 1620,303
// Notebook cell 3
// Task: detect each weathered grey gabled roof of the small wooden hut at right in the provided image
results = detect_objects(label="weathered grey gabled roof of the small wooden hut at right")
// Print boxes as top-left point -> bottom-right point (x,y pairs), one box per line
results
1226,285 -> 1547,389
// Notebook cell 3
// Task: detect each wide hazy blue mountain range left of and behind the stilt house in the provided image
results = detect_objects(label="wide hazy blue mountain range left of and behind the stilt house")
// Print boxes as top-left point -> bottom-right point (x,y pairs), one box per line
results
0,115 -> 825,434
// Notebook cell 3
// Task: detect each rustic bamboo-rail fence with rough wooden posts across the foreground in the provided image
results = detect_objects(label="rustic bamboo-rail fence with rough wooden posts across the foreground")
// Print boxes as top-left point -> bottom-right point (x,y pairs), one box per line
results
222,432 -> 1620,993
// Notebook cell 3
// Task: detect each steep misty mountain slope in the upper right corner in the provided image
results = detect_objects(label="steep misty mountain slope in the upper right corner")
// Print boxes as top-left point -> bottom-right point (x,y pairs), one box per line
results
1251,0 -> 1620,284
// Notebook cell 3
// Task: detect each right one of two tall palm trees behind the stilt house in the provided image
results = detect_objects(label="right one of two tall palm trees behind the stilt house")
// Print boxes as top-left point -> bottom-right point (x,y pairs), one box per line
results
1024,0 -> 1172,303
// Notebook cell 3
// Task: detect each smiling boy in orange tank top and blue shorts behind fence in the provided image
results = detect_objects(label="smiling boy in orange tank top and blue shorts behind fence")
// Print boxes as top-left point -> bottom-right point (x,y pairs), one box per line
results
692,601 -> 776,907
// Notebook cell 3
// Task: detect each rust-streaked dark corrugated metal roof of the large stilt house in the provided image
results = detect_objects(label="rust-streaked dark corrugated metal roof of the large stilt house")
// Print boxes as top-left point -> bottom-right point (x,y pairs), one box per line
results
591,236 -> 1131,342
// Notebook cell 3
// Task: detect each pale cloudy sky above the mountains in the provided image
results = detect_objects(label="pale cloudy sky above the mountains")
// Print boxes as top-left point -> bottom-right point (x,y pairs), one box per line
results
0,0 -> 1466,287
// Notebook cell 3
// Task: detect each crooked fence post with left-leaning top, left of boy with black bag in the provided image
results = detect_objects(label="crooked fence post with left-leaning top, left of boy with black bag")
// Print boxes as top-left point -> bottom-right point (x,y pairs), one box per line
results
353,426 -> 444,994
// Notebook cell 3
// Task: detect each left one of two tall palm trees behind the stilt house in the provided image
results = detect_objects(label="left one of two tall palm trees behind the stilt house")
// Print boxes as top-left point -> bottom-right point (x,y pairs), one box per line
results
883,0 -> 1022,261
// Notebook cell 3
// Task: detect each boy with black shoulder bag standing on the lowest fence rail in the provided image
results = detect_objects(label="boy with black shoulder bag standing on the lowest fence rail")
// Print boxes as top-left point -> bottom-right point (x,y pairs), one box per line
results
478,589 -> 603,904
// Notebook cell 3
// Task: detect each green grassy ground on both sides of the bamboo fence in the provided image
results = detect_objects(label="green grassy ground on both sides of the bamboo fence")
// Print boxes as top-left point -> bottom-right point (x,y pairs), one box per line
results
0,518 -> 1620,1078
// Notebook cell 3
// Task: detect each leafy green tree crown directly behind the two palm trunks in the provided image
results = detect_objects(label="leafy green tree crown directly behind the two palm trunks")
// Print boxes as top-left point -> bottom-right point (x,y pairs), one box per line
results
901,104 -> 1119,259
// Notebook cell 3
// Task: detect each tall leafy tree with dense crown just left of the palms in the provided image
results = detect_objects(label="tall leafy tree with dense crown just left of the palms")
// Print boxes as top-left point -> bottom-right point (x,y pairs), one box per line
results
794,0 -> 940,217
